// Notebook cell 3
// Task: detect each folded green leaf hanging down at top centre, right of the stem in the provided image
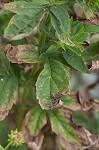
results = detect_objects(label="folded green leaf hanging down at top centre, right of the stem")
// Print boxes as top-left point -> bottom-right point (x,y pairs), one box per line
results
50,6 -> 70,43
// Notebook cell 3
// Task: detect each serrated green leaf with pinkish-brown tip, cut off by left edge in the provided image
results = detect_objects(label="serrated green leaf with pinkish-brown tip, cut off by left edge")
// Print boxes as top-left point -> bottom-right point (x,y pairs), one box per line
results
0,75 -> 18,120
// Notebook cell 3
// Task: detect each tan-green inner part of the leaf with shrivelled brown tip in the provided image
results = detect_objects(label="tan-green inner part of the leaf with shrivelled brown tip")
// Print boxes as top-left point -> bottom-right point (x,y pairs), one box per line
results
16,44 -> 39,63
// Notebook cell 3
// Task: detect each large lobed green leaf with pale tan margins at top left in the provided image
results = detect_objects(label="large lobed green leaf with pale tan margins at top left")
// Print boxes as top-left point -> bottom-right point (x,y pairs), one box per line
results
4,1 -> 45,40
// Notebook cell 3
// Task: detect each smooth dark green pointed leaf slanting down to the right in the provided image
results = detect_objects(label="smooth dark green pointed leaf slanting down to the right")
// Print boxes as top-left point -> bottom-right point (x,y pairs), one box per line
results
63,48 -> 89,73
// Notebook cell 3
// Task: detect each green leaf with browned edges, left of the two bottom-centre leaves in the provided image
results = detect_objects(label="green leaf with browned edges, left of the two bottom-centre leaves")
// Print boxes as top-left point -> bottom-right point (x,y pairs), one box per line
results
27,106 -> 47,136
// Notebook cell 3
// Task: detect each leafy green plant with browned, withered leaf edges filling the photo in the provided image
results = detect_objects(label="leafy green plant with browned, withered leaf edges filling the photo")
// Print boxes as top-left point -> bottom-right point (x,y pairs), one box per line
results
0,0 -> 99,150
